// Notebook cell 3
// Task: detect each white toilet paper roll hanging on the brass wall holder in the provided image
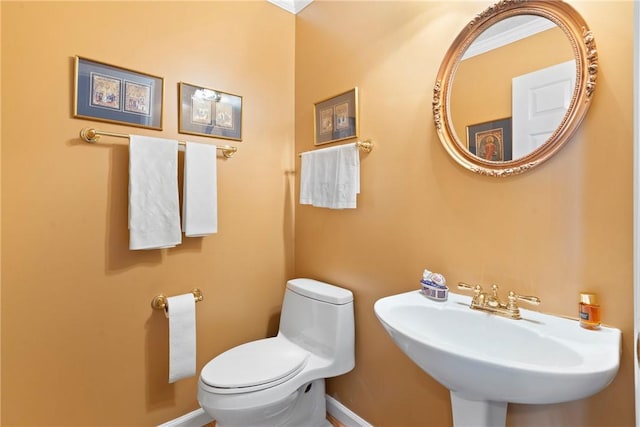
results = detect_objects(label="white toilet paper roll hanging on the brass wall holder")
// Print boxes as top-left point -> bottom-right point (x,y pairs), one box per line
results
166,293 -> 196,383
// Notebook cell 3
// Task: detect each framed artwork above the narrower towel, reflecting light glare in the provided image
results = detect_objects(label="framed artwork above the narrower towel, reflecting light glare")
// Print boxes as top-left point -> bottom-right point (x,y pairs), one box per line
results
178,82 -> 242,141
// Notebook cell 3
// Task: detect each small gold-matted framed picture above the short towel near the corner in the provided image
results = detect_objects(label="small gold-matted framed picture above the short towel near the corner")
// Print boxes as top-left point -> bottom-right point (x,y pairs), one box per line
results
313,87 -> 358,145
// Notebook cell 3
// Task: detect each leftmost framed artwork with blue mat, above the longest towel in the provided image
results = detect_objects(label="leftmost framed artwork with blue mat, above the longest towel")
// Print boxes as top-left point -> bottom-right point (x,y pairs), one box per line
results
73,56 -> 164,130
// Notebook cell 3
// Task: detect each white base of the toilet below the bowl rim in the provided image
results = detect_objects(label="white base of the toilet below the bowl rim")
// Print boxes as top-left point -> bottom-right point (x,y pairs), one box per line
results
209,378 -> 331,427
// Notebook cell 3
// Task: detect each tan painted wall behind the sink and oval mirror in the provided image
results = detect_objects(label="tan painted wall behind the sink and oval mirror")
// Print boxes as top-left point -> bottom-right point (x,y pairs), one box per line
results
295,1 -> 634,427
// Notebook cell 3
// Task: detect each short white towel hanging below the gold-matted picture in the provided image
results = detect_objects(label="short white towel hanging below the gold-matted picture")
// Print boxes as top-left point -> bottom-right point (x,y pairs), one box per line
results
300,143 -> 360,209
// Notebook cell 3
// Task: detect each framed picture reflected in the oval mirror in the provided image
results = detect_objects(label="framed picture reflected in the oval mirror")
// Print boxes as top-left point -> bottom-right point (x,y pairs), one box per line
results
467,117 -> 513,162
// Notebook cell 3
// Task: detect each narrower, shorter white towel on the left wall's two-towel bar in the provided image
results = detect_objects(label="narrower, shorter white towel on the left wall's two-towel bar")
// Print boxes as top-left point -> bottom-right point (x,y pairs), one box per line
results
182,142 -> 218,237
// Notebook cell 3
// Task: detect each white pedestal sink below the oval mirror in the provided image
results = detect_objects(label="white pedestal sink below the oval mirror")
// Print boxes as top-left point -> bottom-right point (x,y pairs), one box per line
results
374,291 -> 621,427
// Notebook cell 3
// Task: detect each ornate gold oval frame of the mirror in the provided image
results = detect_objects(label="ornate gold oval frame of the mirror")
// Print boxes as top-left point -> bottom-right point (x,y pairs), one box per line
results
433,0 -> 598,177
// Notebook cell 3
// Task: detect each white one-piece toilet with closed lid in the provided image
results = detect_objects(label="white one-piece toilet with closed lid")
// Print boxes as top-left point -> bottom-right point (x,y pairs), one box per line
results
198,279 -> 355,427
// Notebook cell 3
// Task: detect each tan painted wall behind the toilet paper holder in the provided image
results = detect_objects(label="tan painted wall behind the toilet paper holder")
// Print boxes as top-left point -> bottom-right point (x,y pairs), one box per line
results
1,1 -> 295,426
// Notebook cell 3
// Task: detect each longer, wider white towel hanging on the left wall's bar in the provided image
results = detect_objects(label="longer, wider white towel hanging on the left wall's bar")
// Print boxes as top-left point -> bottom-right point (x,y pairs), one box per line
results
129,135 -> 182,250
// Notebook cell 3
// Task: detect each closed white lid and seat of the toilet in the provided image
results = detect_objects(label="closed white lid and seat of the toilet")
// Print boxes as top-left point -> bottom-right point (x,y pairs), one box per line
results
200,337 -> 309,394
